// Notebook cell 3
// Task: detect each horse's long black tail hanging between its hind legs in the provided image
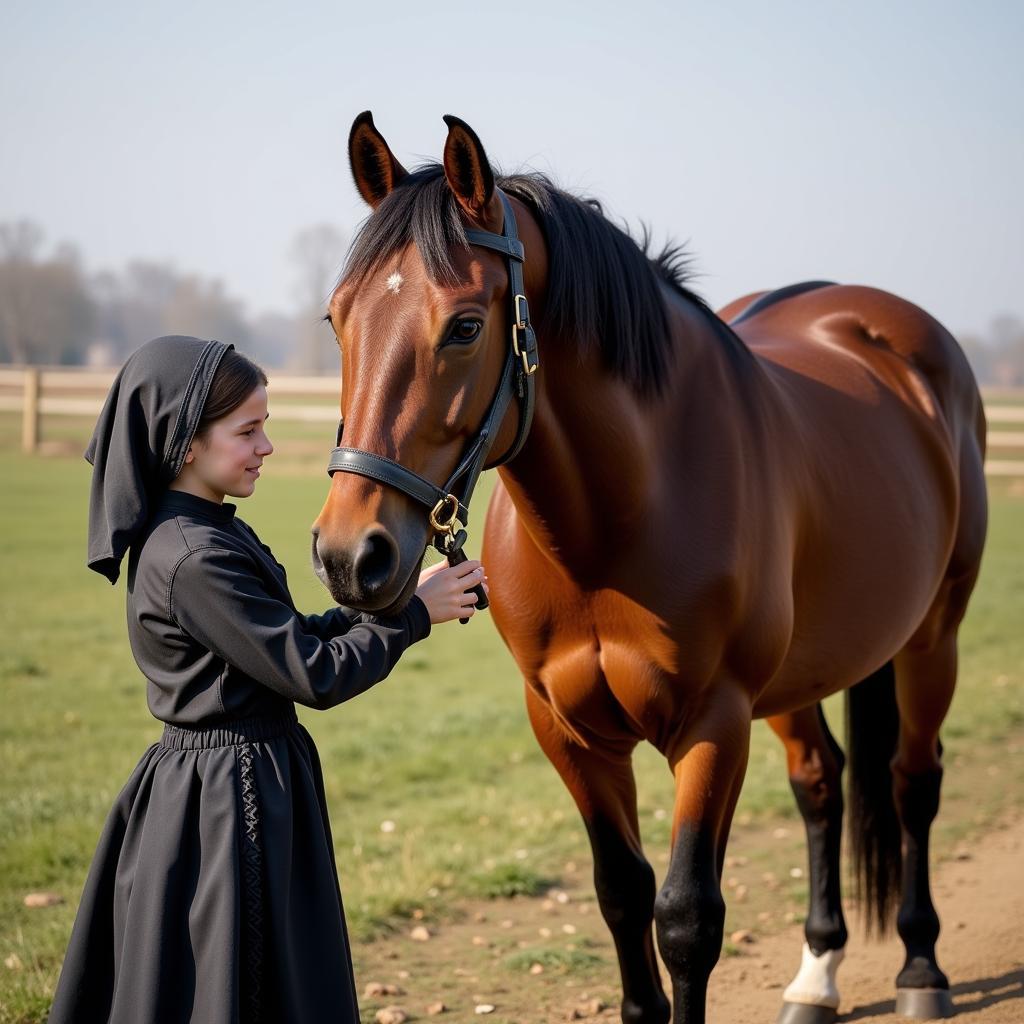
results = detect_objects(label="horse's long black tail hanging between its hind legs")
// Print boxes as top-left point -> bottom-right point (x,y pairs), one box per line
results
846,662 -> 901,935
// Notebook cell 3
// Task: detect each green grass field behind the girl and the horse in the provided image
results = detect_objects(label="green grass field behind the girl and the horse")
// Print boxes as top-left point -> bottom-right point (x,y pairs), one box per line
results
0,417 -> 1024,1024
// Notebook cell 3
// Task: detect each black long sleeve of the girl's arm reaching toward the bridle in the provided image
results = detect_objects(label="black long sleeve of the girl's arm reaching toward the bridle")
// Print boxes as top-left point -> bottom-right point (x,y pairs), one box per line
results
168,547 -> 430,709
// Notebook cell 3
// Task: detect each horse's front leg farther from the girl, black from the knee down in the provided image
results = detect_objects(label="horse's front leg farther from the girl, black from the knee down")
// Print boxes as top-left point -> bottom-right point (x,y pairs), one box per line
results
654,681 -> 751,1024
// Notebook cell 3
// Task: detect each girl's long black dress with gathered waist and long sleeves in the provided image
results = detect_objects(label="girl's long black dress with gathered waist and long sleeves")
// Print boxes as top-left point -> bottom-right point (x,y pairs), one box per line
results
49,490 -> 430,1024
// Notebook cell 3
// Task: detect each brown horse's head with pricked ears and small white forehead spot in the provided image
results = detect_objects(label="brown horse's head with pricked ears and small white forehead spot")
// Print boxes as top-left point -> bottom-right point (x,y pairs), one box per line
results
312,112 -> 545,612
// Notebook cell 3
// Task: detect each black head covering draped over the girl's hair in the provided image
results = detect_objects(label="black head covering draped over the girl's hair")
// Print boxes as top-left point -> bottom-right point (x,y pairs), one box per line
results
85,337 -> 233,583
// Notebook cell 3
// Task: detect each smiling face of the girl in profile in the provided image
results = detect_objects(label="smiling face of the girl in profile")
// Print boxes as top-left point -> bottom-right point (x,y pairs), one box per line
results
174,384 -> 273,502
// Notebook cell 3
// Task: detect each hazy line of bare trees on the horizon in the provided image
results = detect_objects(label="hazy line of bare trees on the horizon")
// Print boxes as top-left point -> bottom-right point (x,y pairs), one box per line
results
0,221 -> 1024,387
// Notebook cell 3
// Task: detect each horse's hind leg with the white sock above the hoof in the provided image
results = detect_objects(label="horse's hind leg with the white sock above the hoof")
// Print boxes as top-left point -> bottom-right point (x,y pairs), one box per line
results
768,705 -> 847,1024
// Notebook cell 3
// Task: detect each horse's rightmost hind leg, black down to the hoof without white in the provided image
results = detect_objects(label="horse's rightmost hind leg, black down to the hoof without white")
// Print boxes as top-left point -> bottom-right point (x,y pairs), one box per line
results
892,632 -> 956,1018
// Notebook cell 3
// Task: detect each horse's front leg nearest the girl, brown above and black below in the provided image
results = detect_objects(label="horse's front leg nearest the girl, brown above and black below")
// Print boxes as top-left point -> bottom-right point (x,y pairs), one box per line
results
526,686 -> 670,1024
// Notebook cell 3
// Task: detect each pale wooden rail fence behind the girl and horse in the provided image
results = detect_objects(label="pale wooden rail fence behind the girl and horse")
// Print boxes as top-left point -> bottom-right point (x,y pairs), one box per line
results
0,367 -> 1024,476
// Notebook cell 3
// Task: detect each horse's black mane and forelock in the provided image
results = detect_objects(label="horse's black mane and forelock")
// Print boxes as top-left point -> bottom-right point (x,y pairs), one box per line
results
344,164 -> 742,393
